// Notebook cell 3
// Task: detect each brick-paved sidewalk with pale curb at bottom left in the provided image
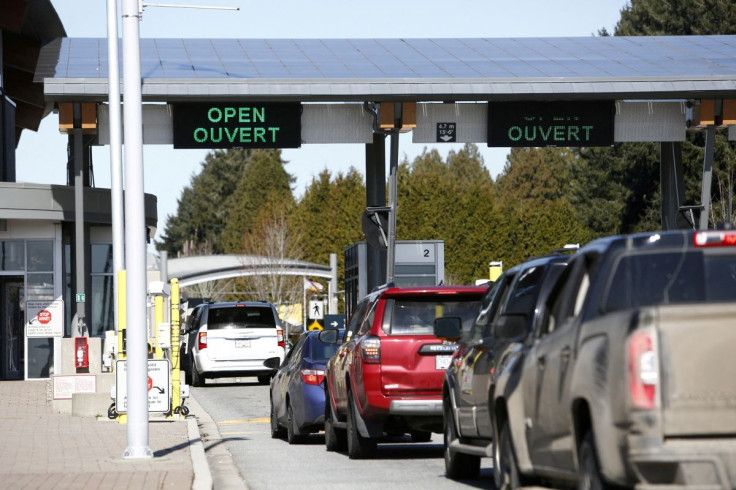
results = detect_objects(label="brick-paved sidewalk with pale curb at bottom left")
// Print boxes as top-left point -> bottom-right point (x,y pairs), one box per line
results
0,380 -> 224,490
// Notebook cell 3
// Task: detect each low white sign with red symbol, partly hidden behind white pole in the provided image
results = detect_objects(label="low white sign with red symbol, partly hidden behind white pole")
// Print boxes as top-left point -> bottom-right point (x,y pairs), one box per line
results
115,359 -> 171,413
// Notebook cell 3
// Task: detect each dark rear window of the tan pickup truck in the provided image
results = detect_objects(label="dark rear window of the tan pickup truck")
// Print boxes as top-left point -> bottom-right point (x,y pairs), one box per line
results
605,251 -> 736,312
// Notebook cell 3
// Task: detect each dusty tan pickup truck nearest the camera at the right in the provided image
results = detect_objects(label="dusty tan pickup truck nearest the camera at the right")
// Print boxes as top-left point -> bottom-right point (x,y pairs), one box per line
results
492,230 -> 736,489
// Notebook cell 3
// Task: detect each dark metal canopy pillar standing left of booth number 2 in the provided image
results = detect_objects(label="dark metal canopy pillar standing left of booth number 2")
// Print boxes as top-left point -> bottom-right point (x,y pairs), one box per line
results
365,133 -> 386,291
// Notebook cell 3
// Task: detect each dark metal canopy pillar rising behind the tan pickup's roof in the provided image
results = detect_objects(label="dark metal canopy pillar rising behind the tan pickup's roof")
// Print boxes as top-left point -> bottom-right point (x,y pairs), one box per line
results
659,142 -> 692,231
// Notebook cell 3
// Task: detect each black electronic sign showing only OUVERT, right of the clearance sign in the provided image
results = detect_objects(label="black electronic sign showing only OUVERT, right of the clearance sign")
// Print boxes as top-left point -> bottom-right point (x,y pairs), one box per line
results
488,100 -> 615,147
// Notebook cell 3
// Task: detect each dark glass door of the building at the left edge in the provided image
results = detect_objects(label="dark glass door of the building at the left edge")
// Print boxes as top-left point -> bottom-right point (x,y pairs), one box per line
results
0,276 -> 26,380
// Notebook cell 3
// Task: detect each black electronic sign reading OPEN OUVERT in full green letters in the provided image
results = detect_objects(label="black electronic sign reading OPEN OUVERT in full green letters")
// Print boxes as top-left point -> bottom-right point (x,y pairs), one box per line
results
173,102 -> 302,148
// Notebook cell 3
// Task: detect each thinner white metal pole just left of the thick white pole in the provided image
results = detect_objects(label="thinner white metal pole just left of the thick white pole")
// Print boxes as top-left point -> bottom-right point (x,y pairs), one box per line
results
107,0 -> 125,335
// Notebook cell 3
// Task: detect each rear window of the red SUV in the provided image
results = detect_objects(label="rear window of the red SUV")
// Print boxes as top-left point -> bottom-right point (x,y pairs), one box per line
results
383,297 -> 481,335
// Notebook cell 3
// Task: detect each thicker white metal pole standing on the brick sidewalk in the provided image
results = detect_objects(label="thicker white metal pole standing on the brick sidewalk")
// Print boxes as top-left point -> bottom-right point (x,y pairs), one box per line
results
123,0 -> 153,459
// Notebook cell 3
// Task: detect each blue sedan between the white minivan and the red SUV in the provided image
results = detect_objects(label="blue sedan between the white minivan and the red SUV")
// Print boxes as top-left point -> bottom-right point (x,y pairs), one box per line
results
270,330 -> 343,444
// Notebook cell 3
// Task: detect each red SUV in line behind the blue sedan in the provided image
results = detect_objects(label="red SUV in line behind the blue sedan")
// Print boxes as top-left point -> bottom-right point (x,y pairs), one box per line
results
325,286 -> 487,459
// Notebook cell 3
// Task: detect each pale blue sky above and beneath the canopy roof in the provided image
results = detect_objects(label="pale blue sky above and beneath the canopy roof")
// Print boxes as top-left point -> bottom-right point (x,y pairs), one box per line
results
16,0 -> 628,245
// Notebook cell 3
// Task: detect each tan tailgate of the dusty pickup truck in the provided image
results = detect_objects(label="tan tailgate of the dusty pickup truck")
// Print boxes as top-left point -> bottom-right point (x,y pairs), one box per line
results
657,303 -> 736,437
